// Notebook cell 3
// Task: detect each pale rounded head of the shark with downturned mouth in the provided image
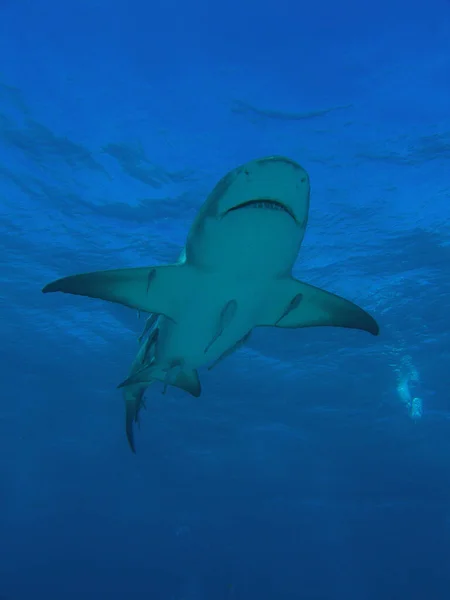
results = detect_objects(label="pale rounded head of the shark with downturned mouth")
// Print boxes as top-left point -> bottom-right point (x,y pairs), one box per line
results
186,156 -> 310,274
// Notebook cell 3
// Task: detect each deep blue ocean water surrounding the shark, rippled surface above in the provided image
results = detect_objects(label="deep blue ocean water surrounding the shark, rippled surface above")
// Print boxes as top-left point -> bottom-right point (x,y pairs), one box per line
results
0,0 -> 450,600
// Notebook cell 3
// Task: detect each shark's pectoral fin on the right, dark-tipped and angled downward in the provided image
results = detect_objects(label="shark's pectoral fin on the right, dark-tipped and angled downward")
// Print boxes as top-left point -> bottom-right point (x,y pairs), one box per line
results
259,278 -> 379,335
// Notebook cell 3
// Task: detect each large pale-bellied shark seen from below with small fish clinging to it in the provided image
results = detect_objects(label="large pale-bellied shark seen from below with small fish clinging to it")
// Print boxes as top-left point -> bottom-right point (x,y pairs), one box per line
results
42,156 -> 379,451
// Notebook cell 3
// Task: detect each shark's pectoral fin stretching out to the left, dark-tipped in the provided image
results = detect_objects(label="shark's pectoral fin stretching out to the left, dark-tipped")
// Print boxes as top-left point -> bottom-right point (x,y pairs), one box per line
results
42,265 -> 192,320
